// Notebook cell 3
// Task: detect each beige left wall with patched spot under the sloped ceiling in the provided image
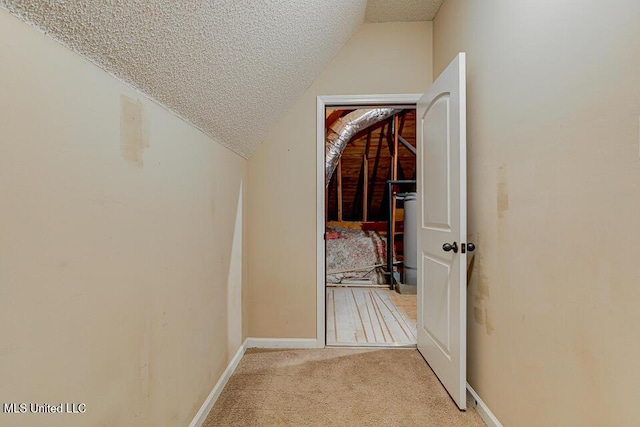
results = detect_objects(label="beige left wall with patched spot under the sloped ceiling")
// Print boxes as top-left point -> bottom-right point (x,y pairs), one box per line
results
0,10 -> 248,427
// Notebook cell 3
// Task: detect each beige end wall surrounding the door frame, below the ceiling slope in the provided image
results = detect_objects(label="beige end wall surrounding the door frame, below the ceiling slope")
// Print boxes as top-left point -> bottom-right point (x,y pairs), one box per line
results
247,22 -> 432,338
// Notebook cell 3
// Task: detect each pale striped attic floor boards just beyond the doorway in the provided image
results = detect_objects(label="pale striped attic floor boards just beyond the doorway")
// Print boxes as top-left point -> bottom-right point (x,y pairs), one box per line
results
326,287 -> 416,347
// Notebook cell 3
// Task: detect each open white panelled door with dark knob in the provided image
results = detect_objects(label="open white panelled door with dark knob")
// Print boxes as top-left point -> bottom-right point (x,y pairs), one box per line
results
417,53 -> 473,409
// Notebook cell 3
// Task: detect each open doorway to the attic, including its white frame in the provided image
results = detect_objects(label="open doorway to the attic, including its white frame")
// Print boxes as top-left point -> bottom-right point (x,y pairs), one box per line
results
317,95 -> 419,348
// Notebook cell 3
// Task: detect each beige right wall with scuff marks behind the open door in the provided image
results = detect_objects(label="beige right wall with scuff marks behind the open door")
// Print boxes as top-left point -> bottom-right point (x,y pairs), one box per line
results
434,0 -> 640,426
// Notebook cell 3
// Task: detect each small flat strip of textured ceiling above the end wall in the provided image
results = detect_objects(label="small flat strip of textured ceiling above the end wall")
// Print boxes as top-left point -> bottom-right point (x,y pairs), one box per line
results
365,0 -> 444,22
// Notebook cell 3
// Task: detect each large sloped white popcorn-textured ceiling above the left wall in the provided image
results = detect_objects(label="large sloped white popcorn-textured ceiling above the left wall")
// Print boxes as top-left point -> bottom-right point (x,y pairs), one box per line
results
0,0 -> 442,157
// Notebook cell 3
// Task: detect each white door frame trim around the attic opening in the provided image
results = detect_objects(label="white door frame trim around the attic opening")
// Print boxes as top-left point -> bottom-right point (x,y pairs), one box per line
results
316,93 -> 423,348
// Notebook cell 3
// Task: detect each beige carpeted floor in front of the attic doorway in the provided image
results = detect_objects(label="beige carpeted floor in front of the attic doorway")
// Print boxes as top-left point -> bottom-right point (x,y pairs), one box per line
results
204,348 -> 485,427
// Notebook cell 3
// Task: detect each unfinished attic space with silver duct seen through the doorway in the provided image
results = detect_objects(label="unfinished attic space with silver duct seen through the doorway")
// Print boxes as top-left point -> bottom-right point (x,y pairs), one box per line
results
325,105 -> 417,346
